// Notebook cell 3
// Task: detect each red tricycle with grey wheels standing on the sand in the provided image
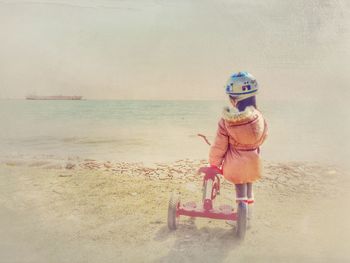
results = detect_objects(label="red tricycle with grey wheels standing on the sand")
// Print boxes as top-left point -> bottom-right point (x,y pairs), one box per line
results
168,167 -> 248,239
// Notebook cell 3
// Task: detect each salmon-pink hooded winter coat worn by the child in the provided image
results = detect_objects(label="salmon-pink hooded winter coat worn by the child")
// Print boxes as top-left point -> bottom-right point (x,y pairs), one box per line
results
209,107 -> 267,184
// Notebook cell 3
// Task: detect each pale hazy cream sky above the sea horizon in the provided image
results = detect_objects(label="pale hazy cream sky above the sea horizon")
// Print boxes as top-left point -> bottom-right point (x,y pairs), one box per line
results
0,0 -> 350,99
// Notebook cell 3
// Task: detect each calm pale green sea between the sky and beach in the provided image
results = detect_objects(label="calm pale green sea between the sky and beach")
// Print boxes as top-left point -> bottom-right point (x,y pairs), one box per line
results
0,100 -> 349,163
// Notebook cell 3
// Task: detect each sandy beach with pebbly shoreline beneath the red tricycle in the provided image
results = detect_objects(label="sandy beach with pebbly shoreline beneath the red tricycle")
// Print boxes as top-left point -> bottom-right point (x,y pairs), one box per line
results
0,159 -> 350,262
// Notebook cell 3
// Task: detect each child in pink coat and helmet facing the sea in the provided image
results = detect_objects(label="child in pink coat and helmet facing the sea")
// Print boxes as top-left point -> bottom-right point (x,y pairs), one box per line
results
209,72 -> 267,225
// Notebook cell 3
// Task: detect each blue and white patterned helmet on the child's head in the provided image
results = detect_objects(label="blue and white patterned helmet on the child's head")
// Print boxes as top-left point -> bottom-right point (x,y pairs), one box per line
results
225,71 -> 258,101
